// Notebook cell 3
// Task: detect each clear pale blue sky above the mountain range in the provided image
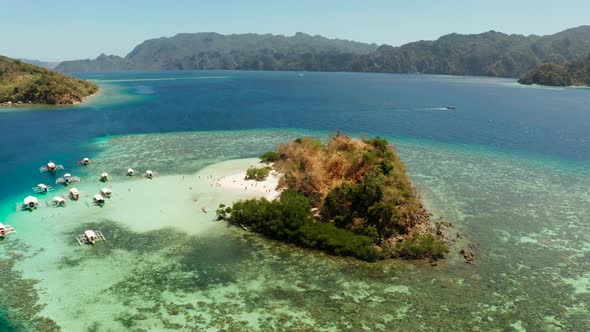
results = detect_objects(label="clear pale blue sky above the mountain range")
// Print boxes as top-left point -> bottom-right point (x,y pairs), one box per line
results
0,0 -> 590,61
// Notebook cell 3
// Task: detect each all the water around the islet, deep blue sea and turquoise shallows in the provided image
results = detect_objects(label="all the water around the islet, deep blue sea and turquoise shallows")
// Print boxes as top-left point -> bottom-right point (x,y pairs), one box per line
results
0,72 -> 590,331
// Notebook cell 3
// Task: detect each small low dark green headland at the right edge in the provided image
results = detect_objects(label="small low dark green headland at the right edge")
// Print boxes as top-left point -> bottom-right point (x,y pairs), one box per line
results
518,56 -> 590,86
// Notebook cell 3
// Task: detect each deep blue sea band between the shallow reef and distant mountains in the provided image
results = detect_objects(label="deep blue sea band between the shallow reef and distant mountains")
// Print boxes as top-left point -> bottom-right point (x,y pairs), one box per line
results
0,71 -> 590,208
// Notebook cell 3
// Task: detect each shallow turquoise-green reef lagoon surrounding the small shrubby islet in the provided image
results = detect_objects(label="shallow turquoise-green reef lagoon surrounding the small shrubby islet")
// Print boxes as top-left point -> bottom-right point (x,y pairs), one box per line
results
0,72 -> 590,331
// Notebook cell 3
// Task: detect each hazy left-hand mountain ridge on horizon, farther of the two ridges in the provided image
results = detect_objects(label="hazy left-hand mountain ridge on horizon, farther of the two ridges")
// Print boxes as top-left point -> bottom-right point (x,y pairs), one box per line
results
56,33 -> 377,72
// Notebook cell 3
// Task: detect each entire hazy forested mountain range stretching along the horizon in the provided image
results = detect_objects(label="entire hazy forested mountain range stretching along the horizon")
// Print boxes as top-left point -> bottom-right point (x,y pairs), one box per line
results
56,26 -> 590,77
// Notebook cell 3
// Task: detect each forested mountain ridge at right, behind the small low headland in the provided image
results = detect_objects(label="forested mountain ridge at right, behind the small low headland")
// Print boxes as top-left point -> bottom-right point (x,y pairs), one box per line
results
356,26 -> 590,77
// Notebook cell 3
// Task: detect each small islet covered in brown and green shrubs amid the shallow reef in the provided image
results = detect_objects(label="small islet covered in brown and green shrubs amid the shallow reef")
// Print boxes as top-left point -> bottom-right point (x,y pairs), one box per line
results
217,132 -> 449,261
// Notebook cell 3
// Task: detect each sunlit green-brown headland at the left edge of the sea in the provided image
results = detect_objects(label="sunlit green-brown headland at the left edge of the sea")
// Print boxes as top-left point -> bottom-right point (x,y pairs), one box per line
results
0,56 -> 99,106
